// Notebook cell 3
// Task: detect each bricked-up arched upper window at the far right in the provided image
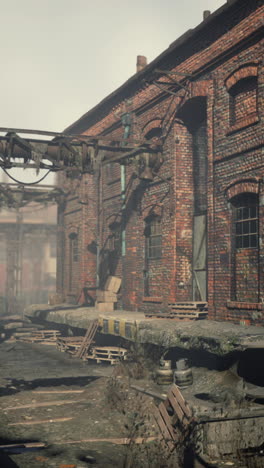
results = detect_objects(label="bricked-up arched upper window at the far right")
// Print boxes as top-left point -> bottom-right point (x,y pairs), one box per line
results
229,76 -> 257,125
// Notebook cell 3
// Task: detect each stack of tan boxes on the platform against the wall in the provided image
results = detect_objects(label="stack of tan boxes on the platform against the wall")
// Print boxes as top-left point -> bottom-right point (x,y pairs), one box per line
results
95,276 -> 121,312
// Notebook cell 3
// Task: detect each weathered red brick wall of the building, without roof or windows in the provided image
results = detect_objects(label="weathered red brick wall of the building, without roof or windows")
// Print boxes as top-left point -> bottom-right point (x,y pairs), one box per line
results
59,2 -> 264,324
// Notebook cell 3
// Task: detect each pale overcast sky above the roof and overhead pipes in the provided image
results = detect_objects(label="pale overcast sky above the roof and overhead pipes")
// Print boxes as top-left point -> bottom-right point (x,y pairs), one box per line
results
0,0 -> 225,183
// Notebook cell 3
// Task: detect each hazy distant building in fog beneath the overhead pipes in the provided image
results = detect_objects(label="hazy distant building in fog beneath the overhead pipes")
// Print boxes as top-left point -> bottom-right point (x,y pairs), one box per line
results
0,184 -> 57,313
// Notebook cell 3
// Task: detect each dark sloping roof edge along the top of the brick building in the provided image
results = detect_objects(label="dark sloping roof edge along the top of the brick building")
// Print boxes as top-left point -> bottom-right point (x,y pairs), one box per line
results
63,0 -> 258,134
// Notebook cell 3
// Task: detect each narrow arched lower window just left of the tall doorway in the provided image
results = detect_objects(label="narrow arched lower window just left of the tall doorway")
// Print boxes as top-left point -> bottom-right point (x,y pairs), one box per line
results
145,216 -> 162,259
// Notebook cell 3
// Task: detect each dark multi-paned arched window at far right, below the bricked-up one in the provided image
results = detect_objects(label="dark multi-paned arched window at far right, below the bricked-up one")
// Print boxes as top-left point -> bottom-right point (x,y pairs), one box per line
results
234,194 -> 258,249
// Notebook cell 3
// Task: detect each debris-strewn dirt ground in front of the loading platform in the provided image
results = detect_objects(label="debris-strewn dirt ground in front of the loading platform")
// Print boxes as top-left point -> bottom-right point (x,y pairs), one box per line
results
0,334 -> 263,468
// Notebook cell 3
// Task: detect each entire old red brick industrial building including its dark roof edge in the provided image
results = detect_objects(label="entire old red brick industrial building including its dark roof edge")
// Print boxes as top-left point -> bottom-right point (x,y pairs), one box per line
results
57,0 -> 264,324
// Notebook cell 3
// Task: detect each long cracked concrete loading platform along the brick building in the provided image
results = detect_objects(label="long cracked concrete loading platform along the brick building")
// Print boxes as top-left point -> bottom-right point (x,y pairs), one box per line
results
24,304 -> 264,355
